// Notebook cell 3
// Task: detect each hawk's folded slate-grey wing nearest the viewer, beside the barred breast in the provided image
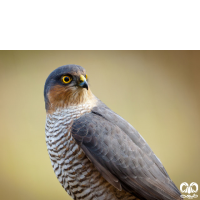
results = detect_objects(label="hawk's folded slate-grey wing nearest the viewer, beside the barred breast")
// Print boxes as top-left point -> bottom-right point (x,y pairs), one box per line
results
71,104 -> 181,200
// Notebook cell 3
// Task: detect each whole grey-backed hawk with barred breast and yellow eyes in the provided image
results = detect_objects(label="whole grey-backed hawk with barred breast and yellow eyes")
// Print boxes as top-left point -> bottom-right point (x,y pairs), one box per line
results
44,64 -> 182,200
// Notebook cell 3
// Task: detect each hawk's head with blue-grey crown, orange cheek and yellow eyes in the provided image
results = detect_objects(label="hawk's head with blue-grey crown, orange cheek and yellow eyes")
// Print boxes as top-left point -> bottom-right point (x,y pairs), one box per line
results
44,65 -> 93,113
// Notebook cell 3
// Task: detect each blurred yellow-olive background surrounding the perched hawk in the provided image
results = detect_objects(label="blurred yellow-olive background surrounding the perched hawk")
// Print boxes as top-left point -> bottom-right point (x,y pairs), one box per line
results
0,51 -> 200,200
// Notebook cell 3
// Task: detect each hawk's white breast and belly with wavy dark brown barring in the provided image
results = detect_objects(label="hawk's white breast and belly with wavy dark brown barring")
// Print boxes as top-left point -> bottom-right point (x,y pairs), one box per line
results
45,104 -> 137,200
